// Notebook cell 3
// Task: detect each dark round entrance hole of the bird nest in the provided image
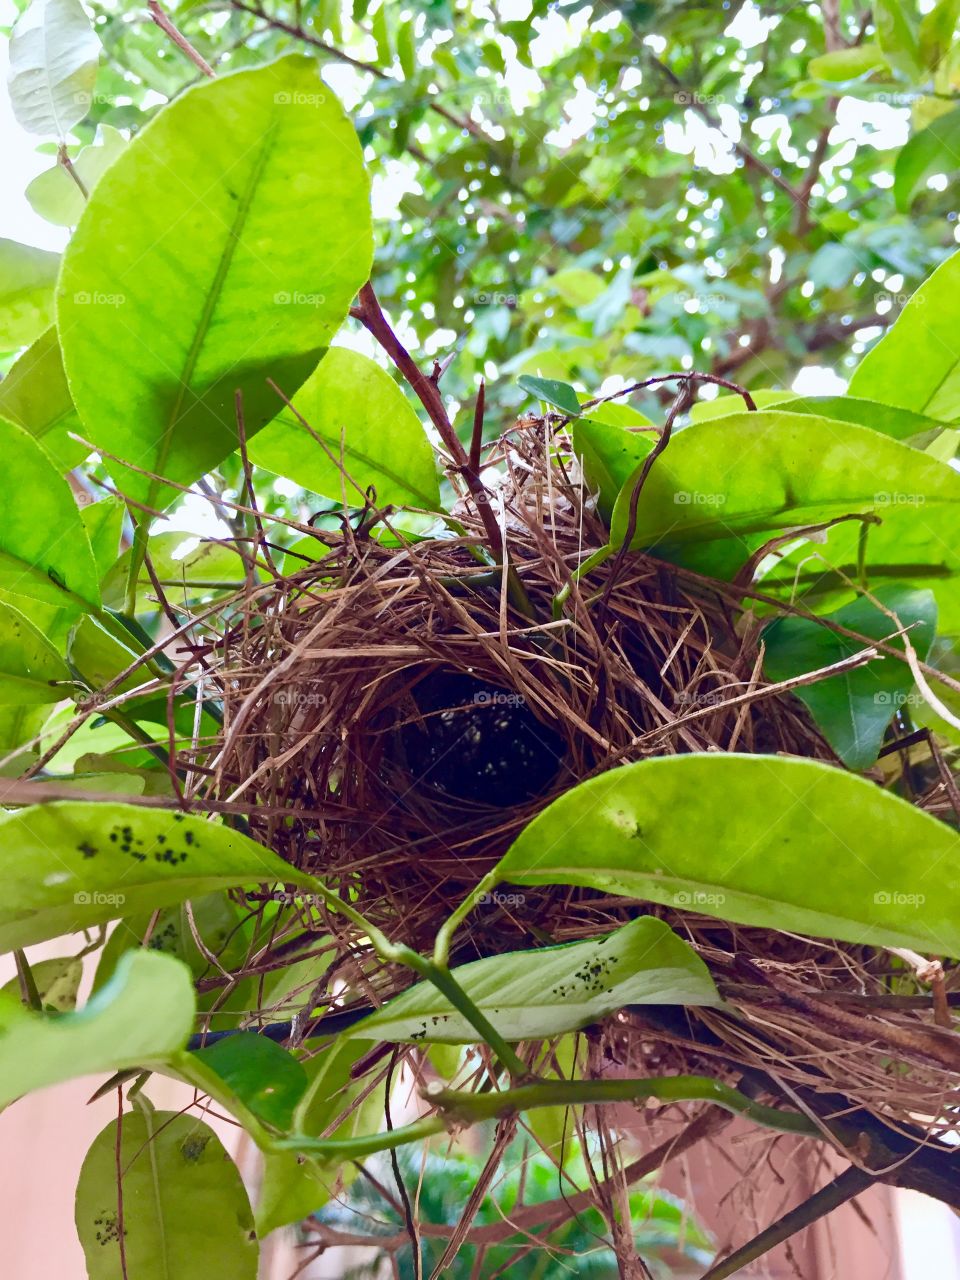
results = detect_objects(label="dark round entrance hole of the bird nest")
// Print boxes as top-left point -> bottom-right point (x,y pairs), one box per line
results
394,667 -> 566,809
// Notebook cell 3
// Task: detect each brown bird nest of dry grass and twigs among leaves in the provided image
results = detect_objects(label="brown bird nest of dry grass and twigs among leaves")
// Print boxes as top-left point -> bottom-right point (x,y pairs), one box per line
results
183,420 -> 960,1152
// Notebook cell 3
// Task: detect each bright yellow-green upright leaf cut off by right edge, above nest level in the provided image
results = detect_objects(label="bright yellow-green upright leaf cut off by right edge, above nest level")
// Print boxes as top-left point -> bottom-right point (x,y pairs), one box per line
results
850,253 -> 960,422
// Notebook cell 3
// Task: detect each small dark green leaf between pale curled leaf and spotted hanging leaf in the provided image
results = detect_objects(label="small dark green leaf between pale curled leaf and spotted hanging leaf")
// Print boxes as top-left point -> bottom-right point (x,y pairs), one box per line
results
193,1032 -> 307,1129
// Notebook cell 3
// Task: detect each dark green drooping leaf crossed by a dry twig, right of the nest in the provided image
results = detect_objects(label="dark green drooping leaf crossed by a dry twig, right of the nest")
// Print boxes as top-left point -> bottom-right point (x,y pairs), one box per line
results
763,585 -> 937,769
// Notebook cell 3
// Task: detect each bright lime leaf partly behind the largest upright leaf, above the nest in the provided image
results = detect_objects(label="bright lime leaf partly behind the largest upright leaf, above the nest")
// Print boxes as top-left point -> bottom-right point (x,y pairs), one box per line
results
250,347 -> 440,508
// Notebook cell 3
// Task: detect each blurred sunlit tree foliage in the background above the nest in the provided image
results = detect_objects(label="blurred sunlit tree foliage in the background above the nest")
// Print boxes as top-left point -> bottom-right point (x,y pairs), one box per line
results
7,0 -> 960,426
